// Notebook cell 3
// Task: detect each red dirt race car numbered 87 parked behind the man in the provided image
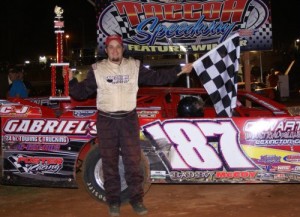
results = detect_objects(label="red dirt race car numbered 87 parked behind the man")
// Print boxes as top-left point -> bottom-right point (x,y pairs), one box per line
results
0,87 -> 300,202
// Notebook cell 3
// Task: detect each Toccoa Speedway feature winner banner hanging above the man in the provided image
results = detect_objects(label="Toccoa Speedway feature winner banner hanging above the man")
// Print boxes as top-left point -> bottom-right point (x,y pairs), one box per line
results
96,0 -> 272,56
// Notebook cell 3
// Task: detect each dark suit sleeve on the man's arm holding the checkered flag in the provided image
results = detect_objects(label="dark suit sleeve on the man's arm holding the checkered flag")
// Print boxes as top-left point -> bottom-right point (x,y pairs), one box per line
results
139,64 -> 181,85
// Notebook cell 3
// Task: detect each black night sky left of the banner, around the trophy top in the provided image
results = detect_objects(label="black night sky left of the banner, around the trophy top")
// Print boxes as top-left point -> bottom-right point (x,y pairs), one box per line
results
0,0 -> 96,62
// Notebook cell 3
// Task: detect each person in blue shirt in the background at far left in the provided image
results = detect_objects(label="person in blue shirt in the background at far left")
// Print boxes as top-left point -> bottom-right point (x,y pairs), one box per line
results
7,69 -> 28,98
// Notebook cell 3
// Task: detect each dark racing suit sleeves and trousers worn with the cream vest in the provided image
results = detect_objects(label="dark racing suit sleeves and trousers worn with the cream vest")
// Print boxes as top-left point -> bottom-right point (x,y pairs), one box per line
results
70,59 -> 180,204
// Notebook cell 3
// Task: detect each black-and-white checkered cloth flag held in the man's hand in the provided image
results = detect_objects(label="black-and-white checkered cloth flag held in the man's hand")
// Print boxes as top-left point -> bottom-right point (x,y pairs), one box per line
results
193,33 -> 240,117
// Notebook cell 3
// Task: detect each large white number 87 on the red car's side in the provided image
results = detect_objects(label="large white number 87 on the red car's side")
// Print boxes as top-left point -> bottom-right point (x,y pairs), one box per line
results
143,120 -> 257,170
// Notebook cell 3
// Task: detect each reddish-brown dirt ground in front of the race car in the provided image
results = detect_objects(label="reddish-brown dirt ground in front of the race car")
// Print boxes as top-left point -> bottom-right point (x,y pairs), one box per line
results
0,176 -> 300,217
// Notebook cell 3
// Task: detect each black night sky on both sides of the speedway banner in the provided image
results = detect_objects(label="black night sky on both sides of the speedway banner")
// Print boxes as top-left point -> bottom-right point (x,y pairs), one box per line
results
0,0 -> 300,63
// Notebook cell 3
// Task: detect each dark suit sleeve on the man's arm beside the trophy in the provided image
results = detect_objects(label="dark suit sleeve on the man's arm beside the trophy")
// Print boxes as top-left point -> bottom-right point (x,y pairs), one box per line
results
69,68 -> 97,100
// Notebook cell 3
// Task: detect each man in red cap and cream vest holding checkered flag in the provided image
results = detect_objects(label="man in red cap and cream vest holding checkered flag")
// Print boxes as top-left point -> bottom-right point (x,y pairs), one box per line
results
70,35 -> 193,216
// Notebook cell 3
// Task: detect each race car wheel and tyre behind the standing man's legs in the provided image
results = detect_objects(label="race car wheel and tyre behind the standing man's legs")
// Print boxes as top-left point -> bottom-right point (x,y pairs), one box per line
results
83,145 -> 151,203
